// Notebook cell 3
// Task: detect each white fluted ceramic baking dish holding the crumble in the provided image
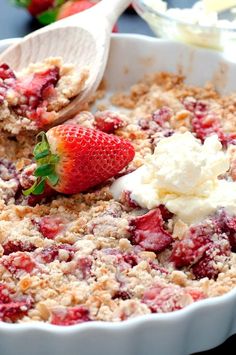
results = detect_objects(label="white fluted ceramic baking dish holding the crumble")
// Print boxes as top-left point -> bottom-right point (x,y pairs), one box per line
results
0,35 -> 236,355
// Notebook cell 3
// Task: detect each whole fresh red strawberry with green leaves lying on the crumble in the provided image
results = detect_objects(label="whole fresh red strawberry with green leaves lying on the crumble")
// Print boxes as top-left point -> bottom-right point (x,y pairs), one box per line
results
24,124 -> 135,195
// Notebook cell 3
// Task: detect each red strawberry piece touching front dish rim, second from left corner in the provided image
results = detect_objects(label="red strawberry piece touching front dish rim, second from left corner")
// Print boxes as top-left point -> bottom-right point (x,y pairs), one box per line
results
51,306 -> 90,326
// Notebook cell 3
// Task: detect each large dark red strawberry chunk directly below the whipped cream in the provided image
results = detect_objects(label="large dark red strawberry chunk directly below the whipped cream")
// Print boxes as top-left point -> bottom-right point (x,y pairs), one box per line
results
129,208 -> 173,253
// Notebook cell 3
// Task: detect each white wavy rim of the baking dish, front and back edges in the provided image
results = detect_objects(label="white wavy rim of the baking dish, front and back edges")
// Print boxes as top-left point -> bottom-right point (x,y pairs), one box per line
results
0,33 -> 236,335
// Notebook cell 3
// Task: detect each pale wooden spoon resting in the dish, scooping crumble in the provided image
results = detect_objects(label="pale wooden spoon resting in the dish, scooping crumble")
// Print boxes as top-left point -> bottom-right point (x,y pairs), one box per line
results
0,0 -> 131,124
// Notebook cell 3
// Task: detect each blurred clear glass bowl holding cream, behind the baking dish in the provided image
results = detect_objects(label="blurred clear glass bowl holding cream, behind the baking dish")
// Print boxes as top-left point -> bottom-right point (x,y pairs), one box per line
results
133,0 -> 236,51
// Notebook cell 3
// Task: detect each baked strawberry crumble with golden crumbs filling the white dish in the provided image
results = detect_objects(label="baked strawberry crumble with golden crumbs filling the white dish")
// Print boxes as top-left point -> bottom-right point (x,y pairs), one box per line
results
0,67 -> 236,326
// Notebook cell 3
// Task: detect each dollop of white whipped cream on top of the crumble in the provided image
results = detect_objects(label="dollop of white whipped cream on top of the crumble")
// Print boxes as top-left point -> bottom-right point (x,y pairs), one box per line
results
111,132 -> 236,224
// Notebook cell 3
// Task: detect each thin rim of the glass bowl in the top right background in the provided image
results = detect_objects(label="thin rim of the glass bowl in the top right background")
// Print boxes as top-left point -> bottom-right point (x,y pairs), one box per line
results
133,0 -> 236,34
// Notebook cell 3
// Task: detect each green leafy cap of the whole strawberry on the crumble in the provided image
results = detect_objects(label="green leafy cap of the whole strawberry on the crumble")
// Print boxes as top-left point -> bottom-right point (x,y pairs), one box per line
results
23,132 -> 59,196
